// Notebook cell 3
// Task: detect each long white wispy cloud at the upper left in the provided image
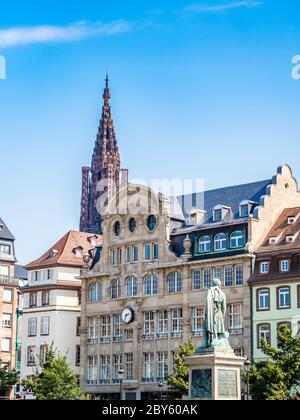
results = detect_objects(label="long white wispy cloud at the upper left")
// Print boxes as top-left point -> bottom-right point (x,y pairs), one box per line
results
0,20 -> 131,48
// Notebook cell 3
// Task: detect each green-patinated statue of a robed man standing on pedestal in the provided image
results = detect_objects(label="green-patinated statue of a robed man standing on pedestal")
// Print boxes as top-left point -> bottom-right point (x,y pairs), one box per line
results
205,279 -> 227,347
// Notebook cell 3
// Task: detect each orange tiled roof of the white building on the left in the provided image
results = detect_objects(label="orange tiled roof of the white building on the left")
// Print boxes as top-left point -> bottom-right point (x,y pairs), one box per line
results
25,230 -> 102,270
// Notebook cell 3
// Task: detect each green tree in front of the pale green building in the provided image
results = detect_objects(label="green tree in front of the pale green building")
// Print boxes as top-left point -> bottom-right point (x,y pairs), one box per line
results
245,326 -> 300,400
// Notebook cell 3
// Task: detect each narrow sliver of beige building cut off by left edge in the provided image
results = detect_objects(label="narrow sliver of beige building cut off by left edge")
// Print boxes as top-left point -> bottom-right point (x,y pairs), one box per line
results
0,218 -> 19,397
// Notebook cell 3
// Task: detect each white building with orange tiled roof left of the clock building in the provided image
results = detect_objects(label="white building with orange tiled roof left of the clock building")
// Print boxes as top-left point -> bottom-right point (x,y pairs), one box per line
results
20,231 -> 100,398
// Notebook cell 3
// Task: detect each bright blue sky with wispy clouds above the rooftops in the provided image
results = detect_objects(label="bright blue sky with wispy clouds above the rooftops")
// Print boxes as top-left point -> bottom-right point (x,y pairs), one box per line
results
0,0 -> 300,263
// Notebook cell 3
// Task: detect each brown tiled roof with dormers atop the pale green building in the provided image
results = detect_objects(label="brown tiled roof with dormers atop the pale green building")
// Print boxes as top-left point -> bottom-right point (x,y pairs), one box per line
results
256,207 -> 300,254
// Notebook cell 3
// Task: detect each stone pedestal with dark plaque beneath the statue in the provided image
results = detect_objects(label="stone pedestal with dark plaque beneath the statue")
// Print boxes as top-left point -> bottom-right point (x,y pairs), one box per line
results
185,351 -> 246,400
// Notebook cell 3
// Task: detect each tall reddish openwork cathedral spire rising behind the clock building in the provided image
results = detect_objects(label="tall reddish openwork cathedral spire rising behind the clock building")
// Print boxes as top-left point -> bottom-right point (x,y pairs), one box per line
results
79,76 -> 128,234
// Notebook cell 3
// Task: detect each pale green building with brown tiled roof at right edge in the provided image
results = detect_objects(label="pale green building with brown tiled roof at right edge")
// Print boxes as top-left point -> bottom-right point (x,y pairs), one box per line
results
249,207 -> 300,360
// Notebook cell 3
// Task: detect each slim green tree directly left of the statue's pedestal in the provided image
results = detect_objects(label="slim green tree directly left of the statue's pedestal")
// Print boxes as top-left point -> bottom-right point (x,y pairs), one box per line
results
167,340 -> 196,395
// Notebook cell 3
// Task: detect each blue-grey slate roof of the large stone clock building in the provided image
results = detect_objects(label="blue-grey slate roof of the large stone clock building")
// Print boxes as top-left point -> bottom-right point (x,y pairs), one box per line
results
177,179 -> 272,223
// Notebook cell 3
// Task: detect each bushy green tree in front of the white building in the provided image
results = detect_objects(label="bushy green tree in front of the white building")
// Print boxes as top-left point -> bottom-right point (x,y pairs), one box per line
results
22,347 -> 83,400
